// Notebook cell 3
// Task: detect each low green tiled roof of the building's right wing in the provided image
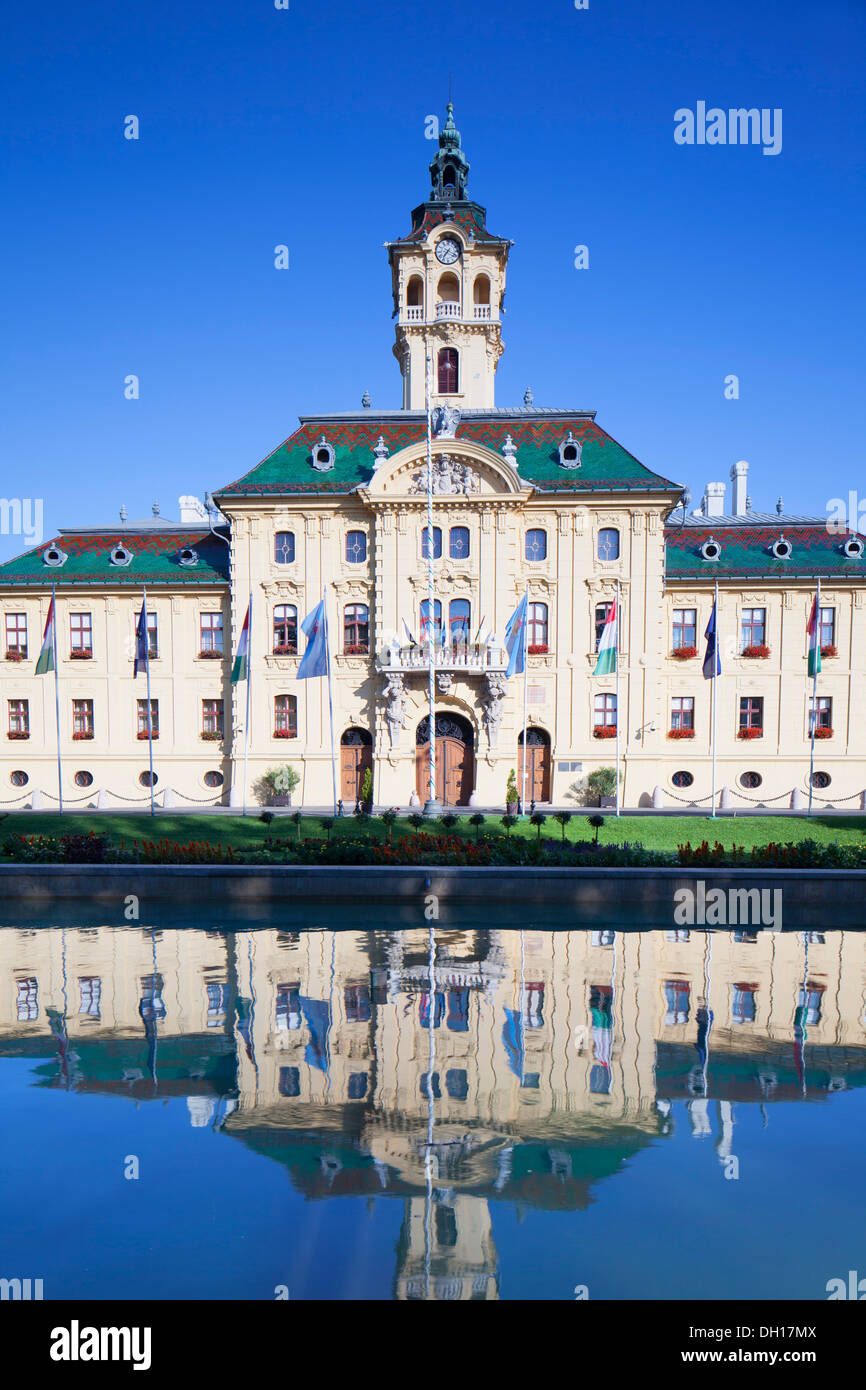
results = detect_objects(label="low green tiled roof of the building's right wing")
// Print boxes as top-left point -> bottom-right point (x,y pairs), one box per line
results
666,516 -> 866,581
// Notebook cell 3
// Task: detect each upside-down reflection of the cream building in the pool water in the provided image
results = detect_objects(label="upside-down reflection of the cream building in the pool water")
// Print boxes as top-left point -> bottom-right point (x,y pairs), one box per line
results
0,927 -> 866,1300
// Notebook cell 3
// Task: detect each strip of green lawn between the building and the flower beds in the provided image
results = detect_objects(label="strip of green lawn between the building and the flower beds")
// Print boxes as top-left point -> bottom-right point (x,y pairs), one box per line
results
0,810 -> 866,849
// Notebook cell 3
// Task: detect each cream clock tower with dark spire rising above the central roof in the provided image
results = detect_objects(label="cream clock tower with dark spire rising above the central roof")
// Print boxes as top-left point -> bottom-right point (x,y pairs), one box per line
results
385,101 -> 512,410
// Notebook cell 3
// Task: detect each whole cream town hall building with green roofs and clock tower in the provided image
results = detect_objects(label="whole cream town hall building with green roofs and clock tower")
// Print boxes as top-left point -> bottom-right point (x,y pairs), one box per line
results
0,106 -> 866,809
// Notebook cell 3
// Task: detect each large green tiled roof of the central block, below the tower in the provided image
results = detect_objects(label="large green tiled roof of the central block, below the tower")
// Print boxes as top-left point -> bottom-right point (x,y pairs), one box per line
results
215,410 -> 677,499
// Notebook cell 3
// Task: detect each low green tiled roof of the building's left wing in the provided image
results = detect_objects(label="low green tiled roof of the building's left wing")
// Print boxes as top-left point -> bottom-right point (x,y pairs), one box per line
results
0,528 -> 228,588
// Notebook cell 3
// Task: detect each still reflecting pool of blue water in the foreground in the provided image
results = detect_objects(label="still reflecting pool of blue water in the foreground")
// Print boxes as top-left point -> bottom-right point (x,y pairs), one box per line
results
0,913 -> 866,1300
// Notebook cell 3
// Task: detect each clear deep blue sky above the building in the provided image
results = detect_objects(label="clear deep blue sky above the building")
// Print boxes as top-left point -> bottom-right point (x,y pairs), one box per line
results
0,0 -> 866,557
